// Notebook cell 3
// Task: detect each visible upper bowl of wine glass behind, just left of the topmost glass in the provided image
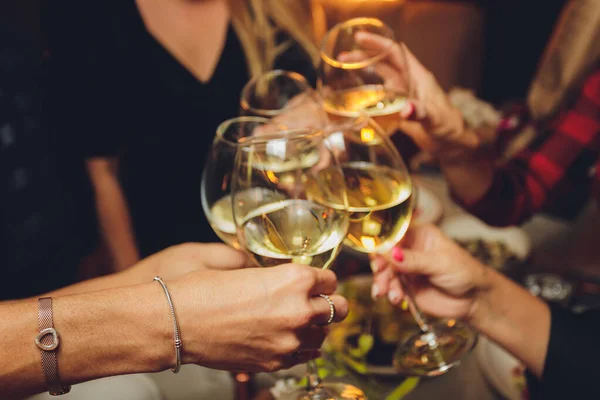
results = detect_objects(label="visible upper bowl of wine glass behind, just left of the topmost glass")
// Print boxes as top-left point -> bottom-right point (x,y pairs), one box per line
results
240,70 -> 328,129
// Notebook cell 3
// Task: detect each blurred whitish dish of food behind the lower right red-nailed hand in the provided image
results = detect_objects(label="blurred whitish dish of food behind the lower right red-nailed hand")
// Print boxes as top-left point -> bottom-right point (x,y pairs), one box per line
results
440,214 -> 532,270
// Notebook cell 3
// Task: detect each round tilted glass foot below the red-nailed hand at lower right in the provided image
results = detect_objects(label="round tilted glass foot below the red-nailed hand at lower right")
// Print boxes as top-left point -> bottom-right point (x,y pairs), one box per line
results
394,319 -> 477,376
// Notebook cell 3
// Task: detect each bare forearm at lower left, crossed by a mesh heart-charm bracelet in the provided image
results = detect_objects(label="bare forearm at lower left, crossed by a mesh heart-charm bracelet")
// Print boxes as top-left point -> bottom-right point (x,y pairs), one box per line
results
0,283 -> 173,398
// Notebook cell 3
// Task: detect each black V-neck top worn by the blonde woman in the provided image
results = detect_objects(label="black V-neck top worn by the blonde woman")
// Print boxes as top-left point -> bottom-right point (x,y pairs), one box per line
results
45,0 -> 314,256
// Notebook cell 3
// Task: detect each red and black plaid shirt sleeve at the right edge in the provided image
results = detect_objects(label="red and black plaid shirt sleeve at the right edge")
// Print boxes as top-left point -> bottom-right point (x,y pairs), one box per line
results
466,68 -> 600,226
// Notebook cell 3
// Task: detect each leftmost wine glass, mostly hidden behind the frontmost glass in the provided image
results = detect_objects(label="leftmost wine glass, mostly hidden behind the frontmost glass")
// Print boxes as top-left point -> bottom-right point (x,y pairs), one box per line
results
200,117 -> 285,249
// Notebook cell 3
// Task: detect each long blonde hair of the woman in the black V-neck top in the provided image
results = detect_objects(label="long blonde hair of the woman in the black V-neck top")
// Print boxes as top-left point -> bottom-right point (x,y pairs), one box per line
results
228,0 -> 319,77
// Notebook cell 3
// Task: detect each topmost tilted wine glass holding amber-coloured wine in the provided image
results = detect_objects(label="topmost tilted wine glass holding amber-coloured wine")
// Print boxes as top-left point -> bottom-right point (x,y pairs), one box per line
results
317,18 -> 411,135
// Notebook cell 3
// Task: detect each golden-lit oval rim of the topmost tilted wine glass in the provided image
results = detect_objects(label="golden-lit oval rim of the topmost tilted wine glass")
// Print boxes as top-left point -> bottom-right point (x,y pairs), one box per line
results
319,17 -> 395,69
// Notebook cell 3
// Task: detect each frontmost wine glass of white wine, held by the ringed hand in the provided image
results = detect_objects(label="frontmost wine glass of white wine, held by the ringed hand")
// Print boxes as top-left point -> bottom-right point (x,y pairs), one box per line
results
232,130 -> 366,400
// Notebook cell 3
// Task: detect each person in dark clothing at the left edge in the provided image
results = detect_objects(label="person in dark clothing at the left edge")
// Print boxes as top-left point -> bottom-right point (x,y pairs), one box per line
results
0,24 -> 93,299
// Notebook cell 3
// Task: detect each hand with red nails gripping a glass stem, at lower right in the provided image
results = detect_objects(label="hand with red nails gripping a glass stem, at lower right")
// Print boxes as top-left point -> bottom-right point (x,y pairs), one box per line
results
371,226 -> 487,320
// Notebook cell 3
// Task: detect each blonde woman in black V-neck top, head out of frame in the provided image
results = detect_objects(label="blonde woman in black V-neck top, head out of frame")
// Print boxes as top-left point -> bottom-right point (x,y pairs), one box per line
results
41,0 -> 318,270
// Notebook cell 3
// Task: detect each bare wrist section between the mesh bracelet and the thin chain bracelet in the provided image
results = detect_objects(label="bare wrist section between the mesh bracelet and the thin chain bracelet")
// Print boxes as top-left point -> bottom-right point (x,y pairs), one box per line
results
55,283 -> 174,383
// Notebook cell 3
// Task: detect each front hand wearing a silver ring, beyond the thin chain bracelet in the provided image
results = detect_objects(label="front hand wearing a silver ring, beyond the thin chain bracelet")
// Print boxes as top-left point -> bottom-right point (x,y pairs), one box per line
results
169,264 -> 348,371
